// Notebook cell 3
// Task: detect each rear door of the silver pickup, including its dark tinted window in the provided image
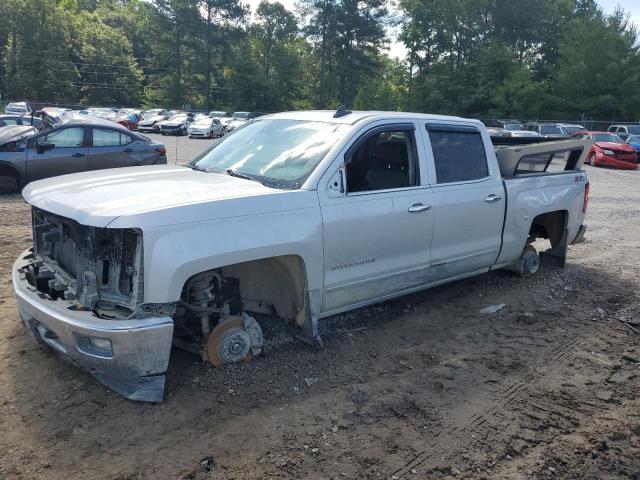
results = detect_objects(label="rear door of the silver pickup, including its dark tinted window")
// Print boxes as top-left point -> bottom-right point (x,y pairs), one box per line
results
425,124 -> 506,280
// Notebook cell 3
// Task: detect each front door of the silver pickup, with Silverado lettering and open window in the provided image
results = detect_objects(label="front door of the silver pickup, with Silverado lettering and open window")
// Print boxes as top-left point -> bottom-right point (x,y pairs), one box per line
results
319,123 -> 433,312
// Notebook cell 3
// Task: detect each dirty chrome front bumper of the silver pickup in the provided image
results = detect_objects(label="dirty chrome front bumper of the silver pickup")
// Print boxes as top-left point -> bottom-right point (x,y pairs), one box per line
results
12,250 -> 173,402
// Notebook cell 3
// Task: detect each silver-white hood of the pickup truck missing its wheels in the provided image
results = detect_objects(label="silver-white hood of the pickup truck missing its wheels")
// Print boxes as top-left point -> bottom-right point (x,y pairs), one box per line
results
22,165 -> 283,228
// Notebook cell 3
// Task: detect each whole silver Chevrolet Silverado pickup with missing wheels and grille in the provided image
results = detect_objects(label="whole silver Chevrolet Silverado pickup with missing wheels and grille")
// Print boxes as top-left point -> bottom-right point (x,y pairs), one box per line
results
13,109 -> 589,401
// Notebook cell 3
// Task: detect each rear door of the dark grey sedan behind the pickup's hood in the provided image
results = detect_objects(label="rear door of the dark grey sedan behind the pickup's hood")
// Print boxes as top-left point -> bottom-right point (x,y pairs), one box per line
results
87,127 -> 141,170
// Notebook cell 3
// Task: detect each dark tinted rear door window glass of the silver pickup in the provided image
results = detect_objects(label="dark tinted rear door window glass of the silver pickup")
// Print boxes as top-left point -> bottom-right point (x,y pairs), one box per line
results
429,130 -> 489,183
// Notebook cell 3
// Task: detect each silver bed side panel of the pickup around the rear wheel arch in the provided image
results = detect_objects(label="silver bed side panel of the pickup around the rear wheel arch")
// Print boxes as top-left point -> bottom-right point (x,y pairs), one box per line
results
496,171 -> 587,267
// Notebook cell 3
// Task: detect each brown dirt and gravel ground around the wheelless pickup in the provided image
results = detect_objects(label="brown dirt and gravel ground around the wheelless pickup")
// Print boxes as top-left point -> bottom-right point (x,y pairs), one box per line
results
0,163 -> 640,480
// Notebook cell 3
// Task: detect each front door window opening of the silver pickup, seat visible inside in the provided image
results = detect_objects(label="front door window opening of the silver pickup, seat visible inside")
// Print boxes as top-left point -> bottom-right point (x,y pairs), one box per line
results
345,130 -> 420,193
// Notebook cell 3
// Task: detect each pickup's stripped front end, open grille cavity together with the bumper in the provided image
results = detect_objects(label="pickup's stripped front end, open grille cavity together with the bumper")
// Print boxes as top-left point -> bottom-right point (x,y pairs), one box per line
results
13,208 -> 175,401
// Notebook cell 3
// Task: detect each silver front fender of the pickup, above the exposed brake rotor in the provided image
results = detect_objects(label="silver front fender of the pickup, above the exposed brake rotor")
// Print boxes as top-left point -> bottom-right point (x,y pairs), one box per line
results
138,192 -> 322,303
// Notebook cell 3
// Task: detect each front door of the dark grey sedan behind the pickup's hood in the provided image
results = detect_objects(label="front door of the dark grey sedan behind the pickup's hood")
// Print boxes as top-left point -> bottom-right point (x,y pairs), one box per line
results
27,125 -> 89,182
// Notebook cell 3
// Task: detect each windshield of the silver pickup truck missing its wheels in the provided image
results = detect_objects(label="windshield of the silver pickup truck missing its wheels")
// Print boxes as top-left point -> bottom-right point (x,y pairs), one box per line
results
190,120 -> 348,189
